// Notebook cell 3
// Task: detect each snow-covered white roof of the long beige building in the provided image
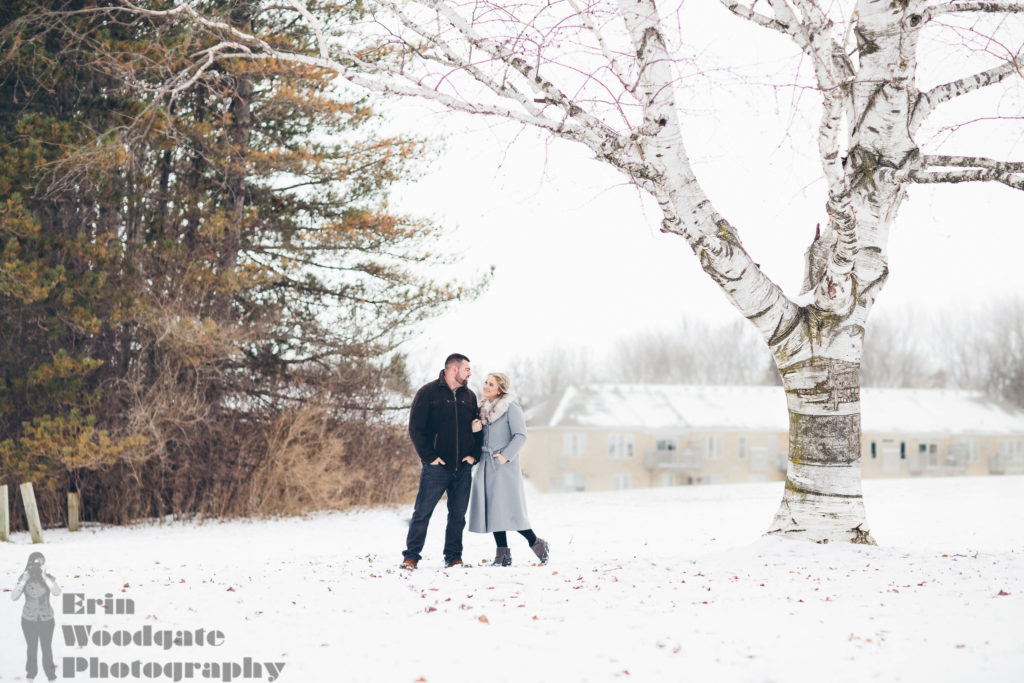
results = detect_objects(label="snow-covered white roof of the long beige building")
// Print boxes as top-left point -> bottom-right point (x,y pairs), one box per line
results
527,384 -> 1024,434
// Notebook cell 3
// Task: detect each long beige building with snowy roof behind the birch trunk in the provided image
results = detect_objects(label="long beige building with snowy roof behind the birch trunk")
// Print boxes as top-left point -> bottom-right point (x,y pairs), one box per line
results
521,384 -> 1024,492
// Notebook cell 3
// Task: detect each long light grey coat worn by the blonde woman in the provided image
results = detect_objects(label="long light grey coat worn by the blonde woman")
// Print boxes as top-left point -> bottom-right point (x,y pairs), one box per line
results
469,401 -> 530,533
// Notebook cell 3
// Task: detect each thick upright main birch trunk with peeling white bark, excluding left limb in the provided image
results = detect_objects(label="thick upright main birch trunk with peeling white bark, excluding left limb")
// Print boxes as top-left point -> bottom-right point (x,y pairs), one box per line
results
769,0 -> 923,544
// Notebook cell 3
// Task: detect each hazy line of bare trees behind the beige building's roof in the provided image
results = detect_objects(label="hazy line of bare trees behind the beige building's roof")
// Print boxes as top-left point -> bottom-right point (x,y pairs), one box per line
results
509,299 -> 1024,407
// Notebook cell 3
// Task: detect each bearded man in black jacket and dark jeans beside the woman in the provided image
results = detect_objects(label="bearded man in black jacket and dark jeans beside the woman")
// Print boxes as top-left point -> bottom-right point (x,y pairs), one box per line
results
401,353 -> 481,569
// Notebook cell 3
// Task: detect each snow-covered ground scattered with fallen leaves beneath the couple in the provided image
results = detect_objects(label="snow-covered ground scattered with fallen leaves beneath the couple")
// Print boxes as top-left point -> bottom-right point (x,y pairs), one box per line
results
0,476 -> 1024,683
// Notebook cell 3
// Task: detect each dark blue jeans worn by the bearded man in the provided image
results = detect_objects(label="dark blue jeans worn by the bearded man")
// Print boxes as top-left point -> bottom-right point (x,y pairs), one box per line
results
402,463 -> 473,562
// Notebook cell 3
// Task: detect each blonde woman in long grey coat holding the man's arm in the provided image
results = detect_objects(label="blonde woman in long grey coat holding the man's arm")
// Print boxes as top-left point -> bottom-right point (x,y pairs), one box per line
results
469,373 -> 548,566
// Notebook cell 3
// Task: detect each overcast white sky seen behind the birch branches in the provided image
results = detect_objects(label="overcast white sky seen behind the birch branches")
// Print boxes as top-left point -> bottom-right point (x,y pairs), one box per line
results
392,2 -> 1024,382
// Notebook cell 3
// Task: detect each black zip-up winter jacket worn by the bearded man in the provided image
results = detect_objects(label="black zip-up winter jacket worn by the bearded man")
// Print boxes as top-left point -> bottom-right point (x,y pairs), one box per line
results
409,371 -> 482,471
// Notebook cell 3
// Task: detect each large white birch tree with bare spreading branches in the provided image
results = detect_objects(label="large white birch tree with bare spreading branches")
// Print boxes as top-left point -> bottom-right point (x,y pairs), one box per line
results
96,0 -> 1024,543
